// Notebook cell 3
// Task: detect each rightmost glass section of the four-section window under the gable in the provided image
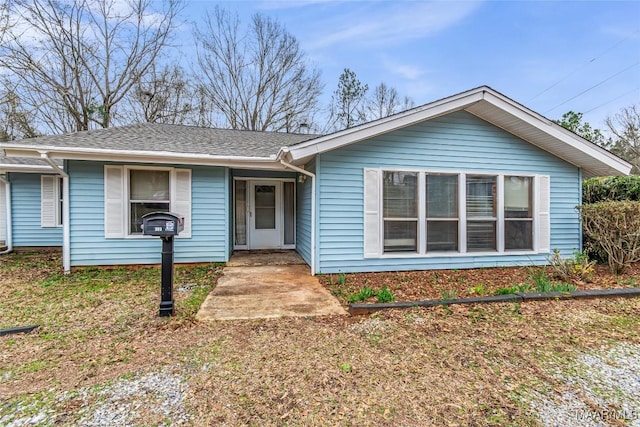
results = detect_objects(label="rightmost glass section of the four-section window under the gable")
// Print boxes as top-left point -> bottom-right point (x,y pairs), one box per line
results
504,176 -> 533,250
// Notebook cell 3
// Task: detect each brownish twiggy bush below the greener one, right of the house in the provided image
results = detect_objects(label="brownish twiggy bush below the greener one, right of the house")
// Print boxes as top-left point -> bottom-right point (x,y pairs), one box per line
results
578,201 -> 640,274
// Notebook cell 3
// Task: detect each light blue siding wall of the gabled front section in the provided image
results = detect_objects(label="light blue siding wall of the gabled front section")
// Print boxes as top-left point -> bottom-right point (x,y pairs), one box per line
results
316,111 -> 580,273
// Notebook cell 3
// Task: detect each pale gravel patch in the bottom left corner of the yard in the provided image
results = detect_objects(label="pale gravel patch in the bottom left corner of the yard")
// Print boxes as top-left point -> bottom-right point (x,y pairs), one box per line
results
0,369 -> 192,427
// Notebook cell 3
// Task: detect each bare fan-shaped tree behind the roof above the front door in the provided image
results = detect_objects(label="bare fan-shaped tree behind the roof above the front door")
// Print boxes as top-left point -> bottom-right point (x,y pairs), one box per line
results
195,8 -> 322,132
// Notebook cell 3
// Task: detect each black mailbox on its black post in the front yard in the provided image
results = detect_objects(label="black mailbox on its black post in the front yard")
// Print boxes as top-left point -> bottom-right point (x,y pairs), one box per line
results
142,212 -> 184,317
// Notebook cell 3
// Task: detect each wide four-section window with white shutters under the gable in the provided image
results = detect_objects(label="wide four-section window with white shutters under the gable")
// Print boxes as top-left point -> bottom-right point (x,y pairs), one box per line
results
363,169 -> 550,258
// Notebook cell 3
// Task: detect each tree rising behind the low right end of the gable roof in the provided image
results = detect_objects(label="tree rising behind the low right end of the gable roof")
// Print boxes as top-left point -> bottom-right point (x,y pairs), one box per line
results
605,105 -> 640,174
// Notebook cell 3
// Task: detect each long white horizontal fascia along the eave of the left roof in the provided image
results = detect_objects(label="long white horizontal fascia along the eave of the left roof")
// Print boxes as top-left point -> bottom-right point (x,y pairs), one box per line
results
2,144 -> 284,170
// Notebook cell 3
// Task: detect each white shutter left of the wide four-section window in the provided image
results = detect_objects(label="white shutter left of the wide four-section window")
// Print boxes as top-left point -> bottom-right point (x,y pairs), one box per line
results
364,168 -> 382,258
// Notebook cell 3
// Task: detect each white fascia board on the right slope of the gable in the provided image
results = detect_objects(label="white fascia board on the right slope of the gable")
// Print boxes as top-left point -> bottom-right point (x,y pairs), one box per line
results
485,90 -> 631,175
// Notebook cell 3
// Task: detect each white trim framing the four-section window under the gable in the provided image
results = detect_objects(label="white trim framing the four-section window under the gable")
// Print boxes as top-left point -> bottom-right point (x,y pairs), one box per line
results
364,167 -> 550,259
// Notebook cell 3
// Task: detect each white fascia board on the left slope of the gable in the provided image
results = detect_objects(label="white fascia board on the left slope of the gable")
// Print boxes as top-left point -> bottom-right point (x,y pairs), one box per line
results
289,87 -> 487,160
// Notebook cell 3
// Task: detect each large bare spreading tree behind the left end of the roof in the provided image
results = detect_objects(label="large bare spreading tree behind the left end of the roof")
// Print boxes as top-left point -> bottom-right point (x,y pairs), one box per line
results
0,0 -> 181,132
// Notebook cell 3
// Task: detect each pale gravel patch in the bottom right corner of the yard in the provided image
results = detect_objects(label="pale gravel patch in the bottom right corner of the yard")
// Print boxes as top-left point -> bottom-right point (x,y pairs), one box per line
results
530,343 -> 640,427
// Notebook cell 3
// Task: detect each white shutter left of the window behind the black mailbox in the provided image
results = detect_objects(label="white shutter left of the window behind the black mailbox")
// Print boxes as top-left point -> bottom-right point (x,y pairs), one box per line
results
104,166 -> 127,239
